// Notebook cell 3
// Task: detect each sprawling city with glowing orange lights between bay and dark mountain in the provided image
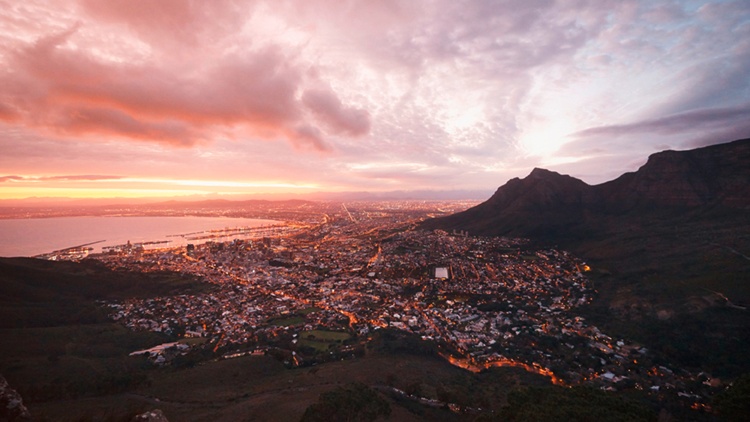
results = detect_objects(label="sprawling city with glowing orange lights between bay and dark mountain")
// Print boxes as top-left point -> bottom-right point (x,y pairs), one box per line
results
61,201 -> 717,409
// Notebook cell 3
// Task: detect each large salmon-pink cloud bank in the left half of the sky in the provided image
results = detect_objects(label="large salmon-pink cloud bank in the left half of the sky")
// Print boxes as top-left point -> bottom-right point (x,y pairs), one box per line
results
0,17 -> 370,151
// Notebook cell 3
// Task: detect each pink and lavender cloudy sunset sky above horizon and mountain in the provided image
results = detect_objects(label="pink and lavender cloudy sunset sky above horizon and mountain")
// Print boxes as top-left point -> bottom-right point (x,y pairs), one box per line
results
0,0 -> 750,199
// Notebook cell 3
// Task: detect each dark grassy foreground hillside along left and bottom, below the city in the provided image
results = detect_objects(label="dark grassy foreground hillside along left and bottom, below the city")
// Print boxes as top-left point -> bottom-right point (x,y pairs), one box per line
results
0,258 -> 664,422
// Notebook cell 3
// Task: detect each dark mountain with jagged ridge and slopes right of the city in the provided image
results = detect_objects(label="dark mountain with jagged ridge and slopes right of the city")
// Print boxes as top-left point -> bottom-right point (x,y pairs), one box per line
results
424,139 -> 750,376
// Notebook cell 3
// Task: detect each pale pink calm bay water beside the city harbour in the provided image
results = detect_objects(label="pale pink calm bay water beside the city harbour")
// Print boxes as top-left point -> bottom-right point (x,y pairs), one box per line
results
0,217 -> 281,257
